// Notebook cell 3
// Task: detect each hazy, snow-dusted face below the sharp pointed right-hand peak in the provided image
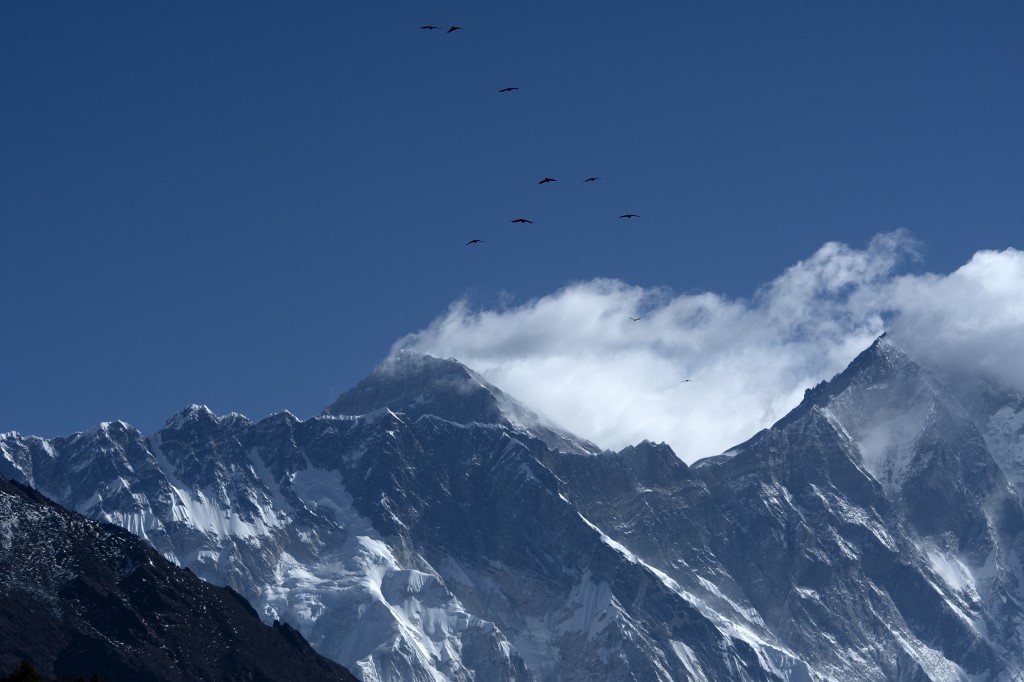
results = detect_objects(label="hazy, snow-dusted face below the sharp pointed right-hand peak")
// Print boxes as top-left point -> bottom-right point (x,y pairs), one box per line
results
805,337 -> 1024,666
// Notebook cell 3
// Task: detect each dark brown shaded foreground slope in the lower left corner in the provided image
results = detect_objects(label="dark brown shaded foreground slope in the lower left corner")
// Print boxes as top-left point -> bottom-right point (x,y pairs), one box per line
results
0,477 -> 355,681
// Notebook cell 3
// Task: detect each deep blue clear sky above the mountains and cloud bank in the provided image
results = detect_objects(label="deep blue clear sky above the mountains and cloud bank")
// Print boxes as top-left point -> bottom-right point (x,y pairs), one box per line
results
0,0 -> 1024,436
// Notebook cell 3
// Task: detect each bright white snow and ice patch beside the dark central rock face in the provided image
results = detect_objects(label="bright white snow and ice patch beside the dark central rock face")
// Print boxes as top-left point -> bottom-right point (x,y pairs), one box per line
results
260,468 -> 512,682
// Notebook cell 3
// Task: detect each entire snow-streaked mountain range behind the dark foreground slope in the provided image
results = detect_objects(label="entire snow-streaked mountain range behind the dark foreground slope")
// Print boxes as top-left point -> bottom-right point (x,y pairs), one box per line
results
0,338 -> 1024,681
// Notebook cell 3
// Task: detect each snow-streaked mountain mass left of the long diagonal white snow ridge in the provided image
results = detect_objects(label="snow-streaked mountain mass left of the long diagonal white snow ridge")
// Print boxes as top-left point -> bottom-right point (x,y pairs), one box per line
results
0,355 -> 782,680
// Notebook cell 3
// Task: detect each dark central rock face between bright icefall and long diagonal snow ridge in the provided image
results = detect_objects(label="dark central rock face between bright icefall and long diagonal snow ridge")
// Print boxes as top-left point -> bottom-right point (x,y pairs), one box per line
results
327,416 -> 772,680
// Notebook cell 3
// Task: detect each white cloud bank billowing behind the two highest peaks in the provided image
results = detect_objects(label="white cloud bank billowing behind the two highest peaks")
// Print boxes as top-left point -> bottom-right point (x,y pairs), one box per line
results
394,230 -> 1024,462
